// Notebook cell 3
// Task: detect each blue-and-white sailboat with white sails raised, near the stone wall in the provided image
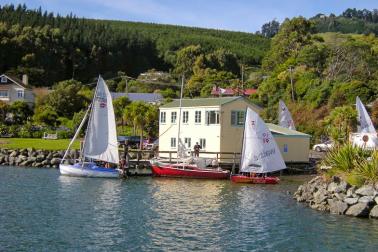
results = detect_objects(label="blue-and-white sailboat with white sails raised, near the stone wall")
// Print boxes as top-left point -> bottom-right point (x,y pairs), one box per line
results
59,76 -> 119,178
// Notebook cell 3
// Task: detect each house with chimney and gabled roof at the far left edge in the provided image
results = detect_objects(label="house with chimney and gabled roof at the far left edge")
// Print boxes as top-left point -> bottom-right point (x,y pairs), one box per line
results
0,74 -> 34,105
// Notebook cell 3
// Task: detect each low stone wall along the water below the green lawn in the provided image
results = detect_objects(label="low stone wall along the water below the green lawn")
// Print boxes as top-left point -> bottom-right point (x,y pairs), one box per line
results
0,148 -> 79,168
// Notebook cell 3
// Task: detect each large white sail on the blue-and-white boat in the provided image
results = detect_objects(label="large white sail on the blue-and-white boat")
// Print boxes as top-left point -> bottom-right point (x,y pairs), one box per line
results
84,76 -> 119,164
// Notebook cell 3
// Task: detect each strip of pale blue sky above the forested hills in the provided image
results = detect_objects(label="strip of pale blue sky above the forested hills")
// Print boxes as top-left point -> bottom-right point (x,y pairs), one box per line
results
0,0 -> 378,32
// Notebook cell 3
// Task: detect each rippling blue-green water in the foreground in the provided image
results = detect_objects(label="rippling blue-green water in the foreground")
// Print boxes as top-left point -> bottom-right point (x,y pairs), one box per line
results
0,167 -> 378,251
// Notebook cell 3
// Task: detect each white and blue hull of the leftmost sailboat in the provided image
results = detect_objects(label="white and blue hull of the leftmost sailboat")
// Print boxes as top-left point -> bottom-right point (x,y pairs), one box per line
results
59,164 -> 119,178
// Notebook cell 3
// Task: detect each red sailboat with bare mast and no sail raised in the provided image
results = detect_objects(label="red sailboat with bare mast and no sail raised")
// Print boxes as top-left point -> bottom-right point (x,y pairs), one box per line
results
150,78 -> 230,179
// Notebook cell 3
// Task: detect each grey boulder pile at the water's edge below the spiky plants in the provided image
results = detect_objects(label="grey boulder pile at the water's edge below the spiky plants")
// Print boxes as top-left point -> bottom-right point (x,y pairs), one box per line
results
294,176 -> 378,218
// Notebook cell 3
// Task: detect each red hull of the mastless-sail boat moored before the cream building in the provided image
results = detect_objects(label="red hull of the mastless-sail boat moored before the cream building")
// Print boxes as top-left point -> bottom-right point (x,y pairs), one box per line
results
151,163 -> 230,179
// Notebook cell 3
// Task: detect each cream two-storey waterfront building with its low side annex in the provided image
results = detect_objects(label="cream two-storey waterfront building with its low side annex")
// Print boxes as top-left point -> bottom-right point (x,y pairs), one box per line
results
159,96 -> 310,162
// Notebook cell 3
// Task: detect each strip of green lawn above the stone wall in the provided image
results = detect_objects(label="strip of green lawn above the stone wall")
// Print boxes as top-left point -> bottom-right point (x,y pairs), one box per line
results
0,138 -> 80,150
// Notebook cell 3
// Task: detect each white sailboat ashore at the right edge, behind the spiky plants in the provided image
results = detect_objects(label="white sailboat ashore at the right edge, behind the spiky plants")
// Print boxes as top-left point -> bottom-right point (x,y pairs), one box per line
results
350,96 -> 378,149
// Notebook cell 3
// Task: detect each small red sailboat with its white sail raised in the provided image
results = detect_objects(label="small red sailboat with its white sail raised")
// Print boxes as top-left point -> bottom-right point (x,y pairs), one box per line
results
231,108 -> 286,184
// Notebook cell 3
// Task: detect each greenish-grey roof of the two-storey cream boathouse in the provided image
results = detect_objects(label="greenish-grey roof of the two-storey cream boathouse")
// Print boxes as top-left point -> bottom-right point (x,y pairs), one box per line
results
160,96 -> 244,108
